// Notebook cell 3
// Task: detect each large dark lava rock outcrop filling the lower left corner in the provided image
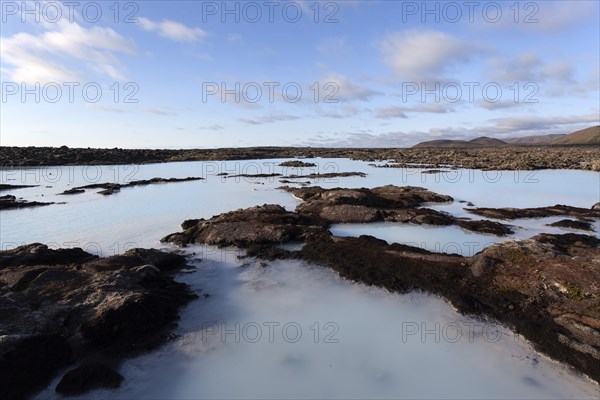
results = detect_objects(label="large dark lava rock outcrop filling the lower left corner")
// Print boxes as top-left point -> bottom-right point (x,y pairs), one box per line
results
0,243 -> 195,399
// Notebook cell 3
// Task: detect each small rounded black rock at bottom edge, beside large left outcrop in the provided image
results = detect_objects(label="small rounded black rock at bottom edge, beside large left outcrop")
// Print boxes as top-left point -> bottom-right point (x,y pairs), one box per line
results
56,364 -> 124,396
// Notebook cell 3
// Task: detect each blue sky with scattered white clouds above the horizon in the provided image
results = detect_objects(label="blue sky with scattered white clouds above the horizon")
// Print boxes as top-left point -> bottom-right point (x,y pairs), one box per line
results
0,0 -> 600,148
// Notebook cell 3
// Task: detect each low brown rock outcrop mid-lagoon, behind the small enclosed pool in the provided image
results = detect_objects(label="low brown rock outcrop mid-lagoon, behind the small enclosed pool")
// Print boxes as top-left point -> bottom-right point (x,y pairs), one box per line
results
162,185 -> 512,247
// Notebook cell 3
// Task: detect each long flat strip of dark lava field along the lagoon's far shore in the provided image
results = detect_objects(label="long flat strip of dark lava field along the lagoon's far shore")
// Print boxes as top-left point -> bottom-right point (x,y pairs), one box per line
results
0,145 -> 600,171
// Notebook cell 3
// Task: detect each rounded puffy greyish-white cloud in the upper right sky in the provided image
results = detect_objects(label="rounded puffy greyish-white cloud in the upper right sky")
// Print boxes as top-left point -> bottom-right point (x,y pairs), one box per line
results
380,30 -> 477,81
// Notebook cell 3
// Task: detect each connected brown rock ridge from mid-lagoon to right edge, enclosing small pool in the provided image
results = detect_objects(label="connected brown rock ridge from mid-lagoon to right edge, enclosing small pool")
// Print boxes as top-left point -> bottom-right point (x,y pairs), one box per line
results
163,186 -> 600,382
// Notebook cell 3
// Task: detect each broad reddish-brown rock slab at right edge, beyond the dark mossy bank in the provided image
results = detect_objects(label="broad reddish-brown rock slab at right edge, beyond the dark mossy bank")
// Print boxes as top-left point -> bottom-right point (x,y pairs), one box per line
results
470,234 -> 600,380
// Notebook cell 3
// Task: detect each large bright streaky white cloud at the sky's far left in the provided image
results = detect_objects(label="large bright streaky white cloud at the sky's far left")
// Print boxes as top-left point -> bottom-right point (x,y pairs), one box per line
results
0,22 -> 135,83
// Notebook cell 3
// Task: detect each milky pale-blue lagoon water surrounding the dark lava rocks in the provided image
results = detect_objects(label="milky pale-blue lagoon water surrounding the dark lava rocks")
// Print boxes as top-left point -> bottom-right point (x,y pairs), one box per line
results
0,159 -> 600,399
